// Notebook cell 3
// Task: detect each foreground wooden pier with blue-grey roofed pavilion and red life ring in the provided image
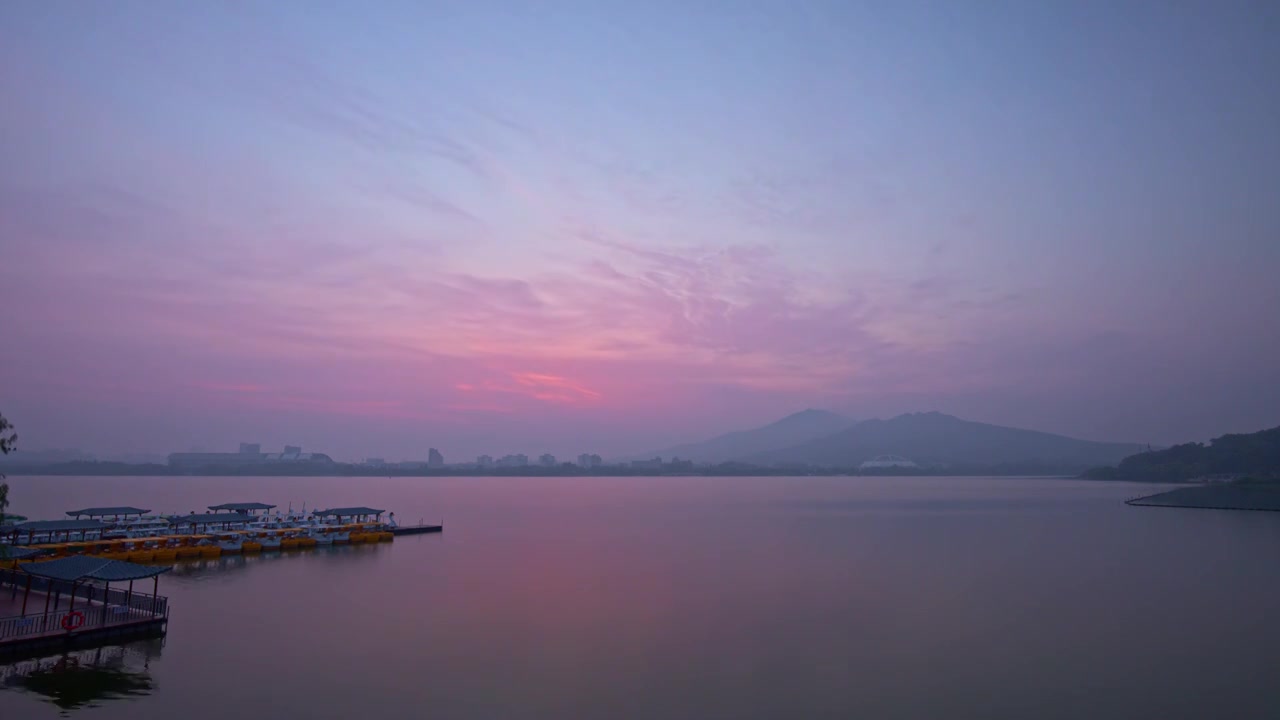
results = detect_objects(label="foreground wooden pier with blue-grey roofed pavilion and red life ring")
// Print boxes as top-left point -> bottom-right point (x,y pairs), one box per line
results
0,556 -> 172,656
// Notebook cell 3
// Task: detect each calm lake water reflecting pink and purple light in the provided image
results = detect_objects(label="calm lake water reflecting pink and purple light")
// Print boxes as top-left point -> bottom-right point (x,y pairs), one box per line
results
0,478 -> 1280,720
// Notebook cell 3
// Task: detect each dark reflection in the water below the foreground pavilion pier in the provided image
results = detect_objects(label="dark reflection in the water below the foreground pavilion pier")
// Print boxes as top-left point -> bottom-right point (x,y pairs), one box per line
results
0,639 -> 164,716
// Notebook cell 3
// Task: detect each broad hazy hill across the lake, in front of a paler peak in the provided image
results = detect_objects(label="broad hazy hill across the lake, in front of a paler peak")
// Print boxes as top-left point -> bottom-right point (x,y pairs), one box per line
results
741,413 -> 1143,473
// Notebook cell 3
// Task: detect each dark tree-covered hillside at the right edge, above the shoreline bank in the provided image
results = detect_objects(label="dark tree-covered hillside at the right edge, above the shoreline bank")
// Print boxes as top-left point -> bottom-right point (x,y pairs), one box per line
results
1087,427 -> 1280,482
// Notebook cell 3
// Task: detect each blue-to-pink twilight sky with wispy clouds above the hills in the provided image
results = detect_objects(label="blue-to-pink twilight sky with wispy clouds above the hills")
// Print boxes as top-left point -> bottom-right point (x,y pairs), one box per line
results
0,0 -> 1280,461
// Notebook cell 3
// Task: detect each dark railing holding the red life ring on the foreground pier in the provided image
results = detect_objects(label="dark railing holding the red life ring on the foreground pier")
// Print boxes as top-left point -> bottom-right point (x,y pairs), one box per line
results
0,570 -> 169,639
